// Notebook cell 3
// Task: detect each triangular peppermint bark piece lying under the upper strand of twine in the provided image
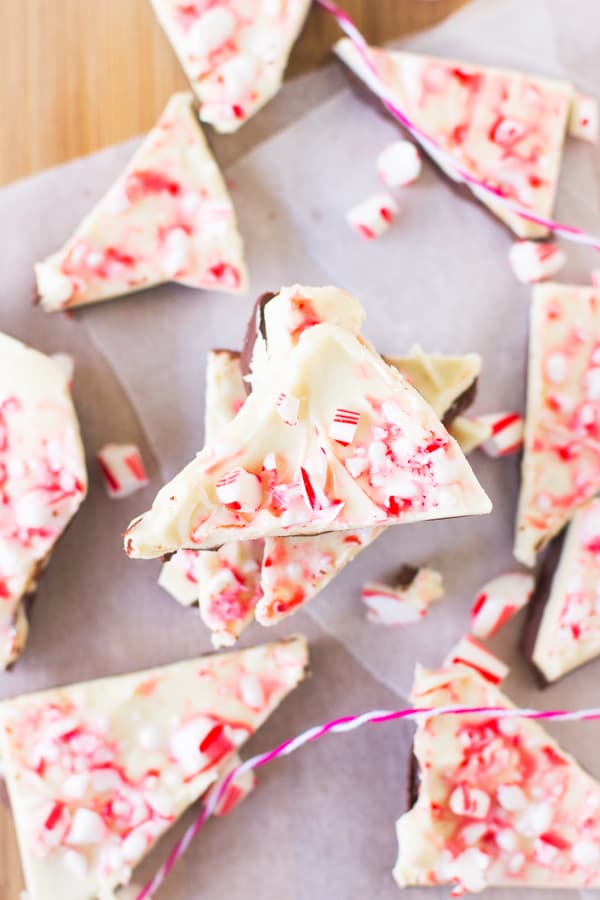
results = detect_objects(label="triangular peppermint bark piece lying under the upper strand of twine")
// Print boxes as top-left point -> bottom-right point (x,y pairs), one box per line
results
335,38 -> 574,237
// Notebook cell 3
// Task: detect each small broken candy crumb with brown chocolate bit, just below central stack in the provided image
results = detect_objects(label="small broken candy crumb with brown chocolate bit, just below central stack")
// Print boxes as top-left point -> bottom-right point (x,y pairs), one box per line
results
361,569 -> 444,625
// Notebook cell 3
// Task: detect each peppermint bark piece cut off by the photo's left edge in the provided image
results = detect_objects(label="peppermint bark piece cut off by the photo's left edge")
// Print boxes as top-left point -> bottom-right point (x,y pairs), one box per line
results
0,333 -> 87,669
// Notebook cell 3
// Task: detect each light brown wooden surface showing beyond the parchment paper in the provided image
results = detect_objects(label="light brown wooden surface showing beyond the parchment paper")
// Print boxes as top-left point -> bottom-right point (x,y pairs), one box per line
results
0,0 -> 465,900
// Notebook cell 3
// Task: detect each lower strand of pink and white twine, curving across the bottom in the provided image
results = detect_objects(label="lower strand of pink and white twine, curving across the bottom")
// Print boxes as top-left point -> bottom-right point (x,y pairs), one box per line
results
136,706 -> 600,900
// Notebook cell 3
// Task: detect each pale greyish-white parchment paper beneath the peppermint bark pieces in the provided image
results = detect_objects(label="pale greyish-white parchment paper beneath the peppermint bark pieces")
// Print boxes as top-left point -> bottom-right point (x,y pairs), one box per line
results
0,0 -> 600,900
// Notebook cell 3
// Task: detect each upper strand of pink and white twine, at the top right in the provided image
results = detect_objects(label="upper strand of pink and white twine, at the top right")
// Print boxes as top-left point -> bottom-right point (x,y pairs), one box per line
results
316,0 -> 600,250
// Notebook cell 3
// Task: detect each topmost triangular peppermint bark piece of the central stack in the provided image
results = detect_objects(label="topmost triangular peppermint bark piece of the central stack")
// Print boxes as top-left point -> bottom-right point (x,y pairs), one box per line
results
125,288 -> 490,558
